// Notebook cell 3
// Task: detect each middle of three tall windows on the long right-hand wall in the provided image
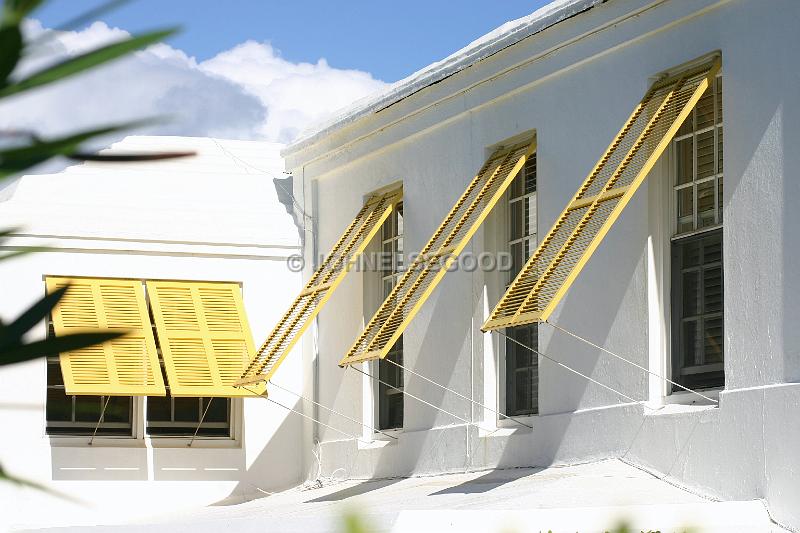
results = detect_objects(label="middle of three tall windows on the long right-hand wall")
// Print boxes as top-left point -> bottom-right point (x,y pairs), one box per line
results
505,153 -> 539,416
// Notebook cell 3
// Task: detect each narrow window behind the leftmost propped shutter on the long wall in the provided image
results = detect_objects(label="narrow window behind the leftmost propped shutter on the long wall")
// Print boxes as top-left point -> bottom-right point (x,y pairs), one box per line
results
378,202 -> 403,429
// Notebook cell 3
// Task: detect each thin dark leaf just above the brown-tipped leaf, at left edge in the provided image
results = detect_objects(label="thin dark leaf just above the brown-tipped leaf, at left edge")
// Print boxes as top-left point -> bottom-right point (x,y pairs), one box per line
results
0,119 -> 155,179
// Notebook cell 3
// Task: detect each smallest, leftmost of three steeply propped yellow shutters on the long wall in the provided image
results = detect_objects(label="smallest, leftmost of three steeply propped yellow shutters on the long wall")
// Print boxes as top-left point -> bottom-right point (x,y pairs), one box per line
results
239,192 -> 402,385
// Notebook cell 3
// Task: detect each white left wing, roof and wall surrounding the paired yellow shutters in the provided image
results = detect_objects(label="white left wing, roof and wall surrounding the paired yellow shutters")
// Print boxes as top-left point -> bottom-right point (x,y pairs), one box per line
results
0,137 -> 305,529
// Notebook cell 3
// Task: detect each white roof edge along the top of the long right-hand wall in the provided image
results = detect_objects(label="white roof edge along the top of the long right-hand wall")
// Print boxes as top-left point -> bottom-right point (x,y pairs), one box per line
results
283,0 -> 607,154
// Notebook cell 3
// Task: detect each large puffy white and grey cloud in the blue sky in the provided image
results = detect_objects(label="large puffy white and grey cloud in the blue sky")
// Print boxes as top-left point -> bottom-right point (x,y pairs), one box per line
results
0,21 -> 386,142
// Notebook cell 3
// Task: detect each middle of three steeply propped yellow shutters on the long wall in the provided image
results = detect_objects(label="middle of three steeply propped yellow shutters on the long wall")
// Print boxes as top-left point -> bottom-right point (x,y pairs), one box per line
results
339,140 -> 536,366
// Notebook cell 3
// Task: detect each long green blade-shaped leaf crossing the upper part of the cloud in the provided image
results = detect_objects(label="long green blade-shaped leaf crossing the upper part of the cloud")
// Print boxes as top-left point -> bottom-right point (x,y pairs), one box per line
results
0,28 -> 177,98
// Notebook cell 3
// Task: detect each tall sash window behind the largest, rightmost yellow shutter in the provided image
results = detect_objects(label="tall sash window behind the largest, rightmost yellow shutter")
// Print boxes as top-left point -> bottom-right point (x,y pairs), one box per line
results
671,76 -> 725,389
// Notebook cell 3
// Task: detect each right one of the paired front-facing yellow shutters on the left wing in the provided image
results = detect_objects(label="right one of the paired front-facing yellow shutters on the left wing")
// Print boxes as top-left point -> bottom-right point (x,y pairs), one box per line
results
147,281 -> 264,397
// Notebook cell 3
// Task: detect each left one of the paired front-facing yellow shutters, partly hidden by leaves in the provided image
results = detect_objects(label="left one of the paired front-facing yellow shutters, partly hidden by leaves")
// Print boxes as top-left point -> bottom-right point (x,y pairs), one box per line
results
46,277 -> 166,396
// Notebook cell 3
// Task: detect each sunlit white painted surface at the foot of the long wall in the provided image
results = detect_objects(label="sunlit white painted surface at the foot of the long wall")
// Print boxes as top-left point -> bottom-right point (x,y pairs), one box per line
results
23,460 -> 782,533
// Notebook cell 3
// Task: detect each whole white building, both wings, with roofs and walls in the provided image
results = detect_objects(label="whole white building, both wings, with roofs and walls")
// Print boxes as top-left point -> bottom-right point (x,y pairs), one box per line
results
0,0 -> 800,529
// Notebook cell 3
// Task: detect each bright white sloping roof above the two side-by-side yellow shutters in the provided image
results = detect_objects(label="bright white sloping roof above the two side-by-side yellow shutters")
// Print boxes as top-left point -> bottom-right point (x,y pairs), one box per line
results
0,136 -> 299,247
